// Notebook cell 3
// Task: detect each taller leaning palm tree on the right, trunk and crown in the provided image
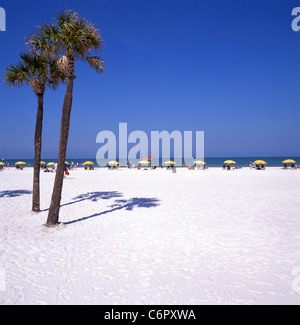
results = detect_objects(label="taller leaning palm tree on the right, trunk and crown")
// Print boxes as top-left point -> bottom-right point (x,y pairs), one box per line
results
27,10 -> 104,227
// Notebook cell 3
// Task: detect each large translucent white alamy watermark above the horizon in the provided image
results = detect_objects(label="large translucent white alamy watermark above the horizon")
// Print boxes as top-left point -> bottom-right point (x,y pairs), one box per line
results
96,123 -> 204,167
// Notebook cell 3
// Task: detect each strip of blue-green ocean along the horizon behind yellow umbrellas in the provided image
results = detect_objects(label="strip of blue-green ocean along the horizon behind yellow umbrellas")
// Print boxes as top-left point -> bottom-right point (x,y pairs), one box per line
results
0,157 -> 300,167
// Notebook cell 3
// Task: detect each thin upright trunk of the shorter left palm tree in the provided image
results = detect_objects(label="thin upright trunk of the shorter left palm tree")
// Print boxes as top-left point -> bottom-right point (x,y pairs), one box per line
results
32,93 -> 44,212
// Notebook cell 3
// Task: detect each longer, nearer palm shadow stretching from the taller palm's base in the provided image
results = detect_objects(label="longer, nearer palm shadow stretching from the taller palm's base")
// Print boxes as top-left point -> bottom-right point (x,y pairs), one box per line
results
64,198 -> 160,225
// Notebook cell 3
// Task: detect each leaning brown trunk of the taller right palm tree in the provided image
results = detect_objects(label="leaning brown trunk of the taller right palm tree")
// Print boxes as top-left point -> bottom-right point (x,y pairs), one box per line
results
46,77 -> 74,227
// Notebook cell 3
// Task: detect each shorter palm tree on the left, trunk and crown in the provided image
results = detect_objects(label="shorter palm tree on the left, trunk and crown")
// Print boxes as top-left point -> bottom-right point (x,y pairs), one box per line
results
5,52 -> 64,212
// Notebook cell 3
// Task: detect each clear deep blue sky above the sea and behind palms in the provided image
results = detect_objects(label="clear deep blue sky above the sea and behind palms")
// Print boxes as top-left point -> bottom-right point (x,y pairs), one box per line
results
0,0 -> 300,159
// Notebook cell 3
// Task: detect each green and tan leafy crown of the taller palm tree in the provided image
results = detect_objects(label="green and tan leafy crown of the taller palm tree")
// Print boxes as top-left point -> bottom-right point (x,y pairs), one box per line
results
27,10 -> 104,79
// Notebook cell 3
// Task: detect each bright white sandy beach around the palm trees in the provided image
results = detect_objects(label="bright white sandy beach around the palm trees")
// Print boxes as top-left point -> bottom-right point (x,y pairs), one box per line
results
0,168 -> 300,305
